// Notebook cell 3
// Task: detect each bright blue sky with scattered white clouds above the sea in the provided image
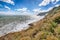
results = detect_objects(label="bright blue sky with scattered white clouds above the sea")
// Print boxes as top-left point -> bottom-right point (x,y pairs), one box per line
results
0,0 -> 60,15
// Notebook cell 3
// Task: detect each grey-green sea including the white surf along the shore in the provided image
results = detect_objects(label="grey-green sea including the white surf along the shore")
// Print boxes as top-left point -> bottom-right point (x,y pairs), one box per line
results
0,15 -> 44,37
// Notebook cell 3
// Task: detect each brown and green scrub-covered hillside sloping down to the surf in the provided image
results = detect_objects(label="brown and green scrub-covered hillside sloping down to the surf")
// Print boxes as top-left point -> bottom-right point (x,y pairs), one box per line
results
0,6 -> 60,40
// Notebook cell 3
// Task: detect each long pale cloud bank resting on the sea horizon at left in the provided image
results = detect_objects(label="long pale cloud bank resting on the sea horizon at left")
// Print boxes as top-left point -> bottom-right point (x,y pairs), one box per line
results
0,6 -> 32,15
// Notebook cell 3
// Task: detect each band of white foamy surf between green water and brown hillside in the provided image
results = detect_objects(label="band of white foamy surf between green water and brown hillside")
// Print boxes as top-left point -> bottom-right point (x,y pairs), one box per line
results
0,16 -> 44,37
